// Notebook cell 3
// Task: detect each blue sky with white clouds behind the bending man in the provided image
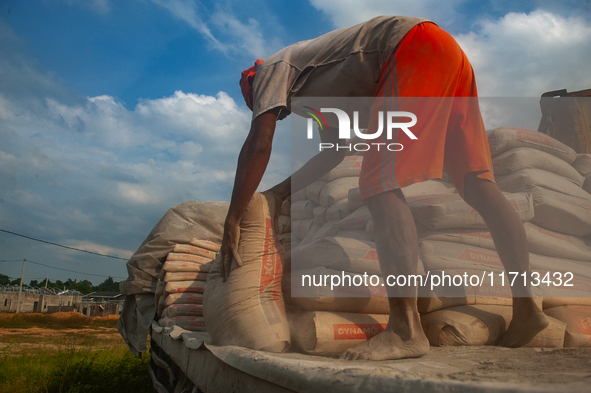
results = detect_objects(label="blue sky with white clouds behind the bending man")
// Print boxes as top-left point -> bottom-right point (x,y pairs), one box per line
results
0,0 -> 591,284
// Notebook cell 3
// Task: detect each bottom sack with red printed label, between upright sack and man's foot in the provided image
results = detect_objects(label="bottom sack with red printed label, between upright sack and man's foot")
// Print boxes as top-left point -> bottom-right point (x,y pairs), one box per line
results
290,311 -> 388,356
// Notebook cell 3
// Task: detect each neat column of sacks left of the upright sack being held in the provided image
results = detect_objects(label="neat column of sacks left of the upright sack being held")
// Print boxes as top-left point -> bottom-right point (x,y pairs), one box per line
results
155,239 -> 220,331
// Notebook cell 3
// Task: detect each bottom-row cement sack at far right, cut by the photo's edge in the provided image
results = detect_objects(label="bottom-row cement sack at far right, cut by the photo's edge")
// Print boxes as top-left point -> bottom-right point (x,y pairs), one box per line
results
544,306 -> 591,348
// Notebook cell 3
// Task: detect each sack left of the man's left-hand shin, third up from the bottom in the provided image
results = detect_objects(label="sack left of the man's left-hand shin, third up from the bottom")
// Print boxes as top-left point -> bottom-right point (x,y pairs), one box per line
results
291,237 -> 381,276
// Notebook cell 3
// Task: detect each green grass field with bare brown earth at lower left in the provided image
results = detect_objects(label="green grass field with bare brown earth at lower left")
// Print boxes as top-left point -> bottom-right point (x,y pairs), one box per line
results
0,313 -> 152,393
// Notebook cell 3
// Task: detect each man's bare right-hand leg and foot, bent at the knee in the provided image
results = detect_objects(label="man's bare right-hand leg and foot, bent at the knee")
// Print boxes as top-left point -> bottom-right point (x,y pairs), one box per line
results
464,173 -> 548,347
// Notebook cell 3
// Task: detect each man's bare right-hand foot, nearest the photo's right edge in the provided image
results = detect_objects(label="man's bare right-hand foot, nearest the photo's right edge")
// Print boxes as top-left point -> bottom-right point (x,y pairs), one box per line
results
497,298 -> 549,347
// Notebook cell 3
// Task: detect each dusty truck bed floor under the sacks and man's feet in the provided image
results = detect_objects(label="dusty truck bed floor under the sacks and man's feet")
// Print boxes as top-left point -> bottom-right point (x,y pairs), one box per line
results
151,323 -> 591,393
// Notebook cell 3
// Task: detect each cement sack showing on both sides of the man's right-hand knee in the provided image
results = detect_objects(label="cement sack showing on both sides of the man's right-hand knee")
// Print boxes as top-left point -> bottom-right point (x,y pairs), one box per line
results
407,193 -> 534,230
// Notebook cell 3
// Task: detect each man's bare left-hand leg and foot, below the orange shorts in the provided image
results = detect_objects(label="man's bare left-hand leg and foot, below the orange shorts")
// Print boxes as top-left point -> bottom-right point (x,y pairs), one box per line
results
341,189 -> 429,360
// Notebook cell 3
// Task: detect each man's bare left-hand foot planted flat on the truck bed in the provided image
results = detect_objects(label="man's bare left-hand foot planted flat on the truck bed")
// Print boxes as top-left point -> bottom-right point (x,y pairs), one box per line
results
340,327 -> 429,360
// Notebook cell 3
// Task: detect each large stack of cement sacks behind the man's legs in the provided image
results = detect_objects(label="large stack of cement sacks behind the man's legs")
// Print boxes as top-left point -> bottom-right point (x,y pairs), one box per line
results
285,128 -> 591,356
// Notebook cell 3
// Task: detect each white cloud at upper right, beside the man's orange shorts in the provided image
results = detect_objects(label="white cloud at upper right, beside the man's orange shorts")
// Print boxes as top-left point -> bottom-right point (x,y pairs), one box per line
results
456,10 -> 591,97
